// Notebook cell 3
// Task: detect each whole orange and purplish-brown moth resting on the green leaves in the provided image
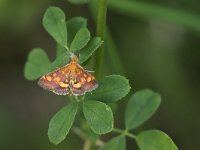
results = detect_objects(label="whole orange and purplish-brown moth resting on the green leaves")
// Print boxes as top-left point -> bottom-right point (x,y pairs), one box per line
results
38,54 -> 98,96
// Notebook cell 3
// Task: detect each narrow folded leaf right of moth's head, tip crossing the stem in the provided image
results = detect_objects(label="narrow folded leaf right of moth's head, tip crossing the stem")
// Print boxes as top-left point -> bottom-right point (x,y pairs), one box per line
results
78,37 -> 103,64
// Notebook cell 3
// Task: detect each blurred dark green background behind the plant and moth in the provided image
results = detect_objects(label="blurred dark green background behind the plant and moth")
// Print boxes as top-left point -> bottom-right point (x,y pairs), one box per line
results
0,0 -> 200,150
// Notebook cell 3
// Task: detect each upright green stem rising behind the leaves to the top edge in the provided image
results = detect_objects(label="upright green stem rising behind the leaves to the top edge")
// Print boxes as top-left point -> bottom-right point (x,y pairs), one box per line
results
95,0 -> 107,78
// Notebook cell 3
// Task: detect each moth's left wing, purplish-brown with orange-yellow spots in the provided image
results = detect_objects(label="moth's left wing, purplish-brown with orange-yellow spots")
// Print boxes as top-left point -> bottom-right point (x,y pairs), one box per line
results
38,65 -> 69,95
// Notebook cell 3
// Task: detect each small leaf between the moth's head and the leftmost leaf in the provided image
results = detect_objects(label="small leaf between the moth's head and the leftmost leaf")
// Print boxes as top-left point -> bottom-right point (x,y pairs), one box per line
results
51,51 -> 70,71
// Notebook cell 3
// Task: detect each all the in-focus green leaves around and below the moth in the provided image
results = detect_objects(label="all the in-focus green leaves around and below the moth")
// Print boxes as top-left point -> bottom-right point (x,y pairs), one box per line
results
24,4 -> 177,150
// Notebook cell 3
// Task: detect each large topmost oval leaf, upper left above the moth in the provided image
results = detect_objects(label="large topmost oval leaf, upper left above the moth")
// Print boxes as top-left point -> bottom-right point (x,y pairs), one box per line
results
43,7 -> 67,48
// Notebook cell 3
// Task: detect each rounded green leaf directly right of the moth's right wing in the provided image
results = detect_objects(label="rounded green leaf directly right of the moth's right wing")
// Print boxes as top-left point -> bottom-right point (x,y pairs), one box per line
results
86,75 -> 130,103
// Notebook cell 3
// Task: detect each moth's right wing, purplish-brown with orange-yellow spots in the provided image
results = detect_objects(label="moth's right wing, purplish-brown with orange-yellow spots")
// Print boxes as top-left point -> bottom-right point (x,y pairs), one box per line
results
71,64 -> 98,95
